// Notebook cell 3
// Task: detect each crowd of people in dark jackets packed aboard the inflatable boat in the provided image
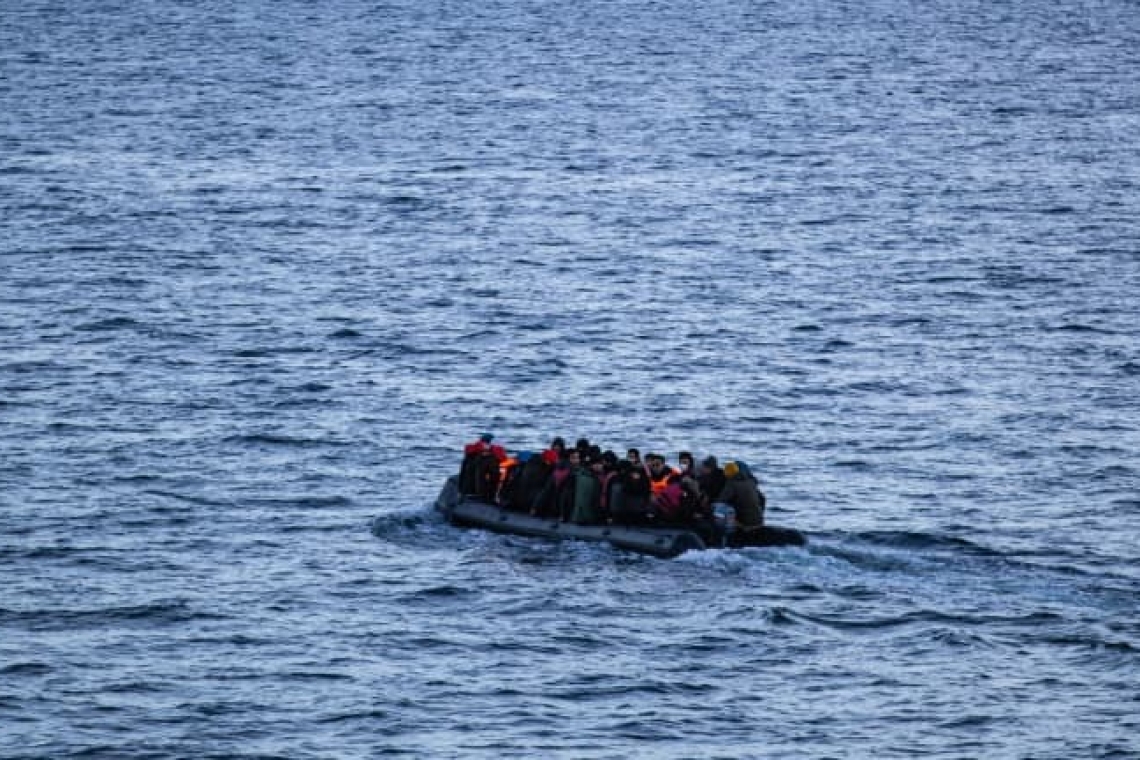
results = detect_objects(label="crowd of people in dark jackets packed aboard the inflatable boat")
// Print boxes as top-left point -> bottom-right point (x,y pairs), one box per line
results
459,433 -> 765,533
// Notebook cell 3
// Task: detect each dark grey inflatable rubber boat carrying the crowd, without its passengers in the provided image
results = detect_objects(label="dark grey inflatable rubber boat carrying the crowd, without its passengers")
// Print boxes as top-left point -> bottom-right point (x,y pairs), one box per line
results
435,477 -> 807,558
